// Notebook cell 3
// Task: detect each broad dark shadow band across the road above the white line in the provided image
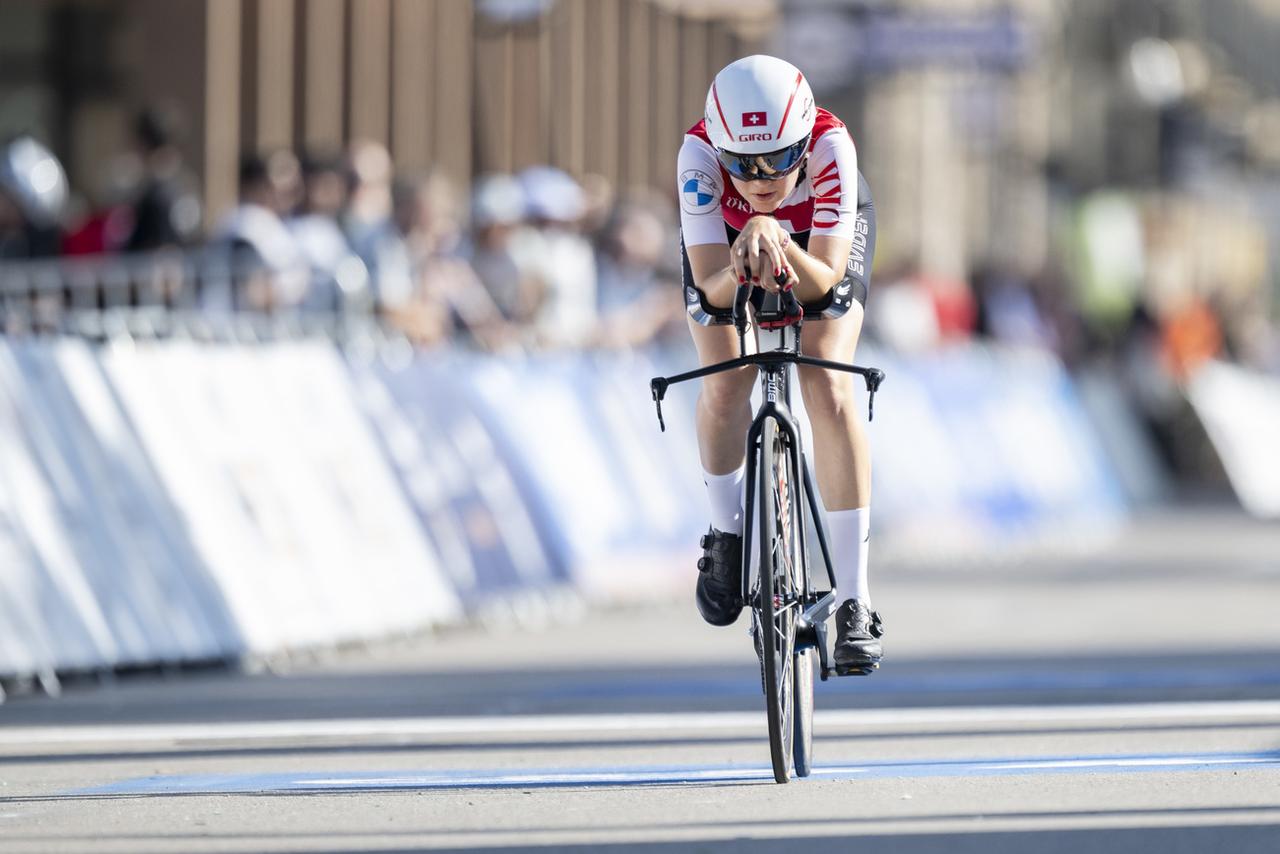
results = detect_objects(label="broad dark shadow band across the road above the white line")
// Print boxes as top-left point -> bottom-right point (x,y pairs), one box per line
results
0,648 -> 1280,725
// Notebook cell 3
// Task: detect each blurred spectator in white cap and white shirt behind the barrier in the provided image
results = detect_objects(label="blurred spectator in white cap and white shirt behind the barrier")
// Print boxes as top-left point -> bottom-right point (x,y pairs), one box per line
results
513,166 -> 598,347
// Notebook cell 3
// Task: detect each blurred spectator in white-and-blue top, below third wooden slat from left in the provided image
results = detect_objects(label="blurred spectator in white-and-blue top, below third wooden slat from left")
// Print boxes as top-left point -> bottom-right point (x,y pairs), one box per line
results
287,155 -> 369,311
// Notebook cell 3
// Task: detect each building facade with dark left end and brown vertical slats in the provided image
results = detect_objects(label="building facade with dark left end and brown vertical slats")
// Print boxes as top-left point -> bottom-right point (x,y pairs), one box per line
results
0,0 -> 776,222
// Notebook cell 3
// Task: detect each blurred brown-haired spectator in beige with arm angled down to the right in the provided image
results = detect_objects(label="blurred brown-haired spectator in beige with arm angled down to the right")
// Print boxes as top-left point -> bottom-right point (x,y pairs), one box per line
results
387,174 -> 512,350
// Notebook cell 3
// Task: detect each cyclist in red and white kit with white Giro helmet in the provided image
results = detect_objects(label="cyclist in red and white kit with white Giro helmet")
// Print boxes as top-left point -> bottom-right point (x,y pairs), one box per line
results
677,55 -> 883,673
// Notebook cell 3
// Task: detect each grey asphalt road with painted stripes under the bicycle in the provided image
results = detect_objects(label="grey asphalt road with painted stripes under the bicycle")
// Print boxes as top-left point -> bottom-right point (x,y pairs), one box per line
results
0,510 -> 1280,854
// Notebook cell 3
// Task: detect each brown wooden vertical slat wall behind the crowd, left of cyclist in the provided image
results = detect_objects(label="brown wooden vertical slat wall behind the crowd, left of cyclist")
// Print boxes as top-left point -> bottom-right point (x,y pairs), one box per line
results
206,0 -> 759,213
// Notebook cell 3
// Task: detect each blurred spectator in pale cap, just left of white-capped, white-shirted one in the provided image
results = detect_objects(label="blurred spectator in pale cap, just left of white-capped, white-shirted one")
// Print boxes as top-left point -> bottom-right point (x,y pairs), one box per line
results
465,174 -> 541,324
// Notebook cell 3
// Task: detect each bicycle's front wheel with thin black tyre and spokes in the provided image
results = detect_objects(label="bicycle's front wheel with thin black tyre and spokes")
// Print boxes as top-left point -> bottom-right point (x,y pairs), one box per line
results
759,419 -> 799,782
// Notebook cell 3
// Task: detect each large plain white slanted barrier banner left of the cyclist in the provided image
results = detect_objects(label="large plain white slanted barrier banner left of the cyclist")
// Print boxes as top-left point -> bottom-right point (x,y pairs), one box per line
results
104,342 -> 458,652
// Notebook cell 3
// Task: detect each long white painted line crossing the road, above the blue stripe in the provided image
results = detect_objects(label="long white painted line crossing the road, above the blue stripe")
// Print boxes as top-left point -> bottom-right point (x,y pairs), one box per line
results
0,700 -> 1280,749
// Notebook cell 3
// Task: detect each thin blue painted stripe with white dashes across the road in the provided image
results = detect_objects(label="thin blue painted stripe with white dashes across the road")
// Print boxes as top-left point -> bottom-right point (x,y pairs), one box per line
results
67,752 -> 1280,796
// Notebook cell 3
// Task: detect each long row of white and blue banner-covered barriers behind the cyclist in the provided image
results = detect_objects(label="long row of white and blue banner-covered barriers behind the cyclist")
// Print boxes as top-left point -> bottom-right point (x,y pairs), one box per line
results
0,338 -> 1126,677
